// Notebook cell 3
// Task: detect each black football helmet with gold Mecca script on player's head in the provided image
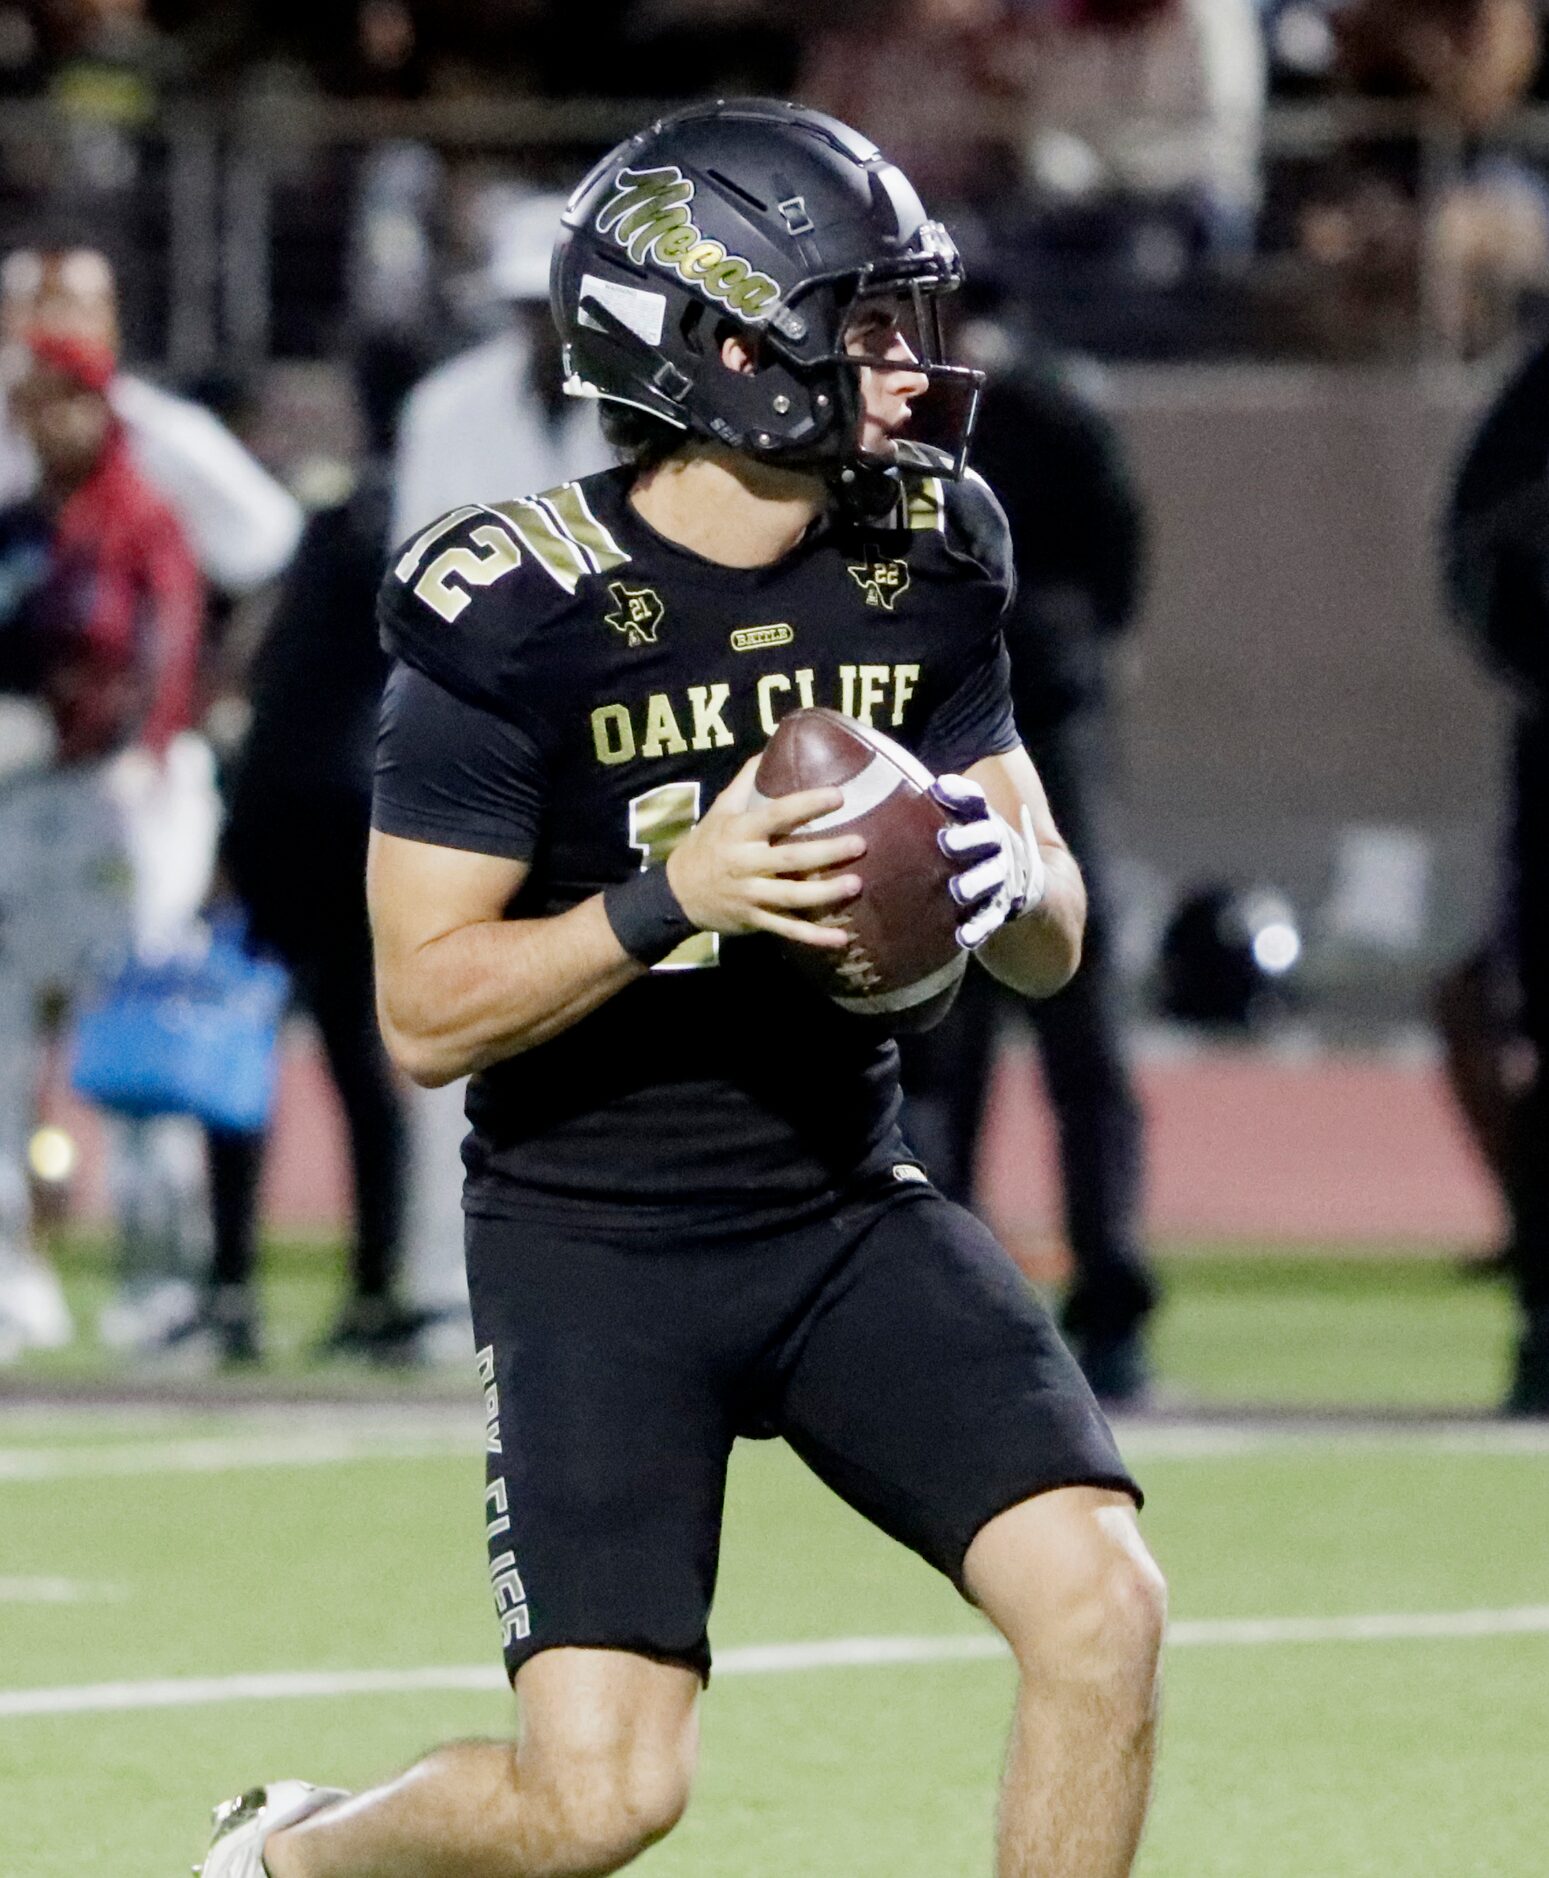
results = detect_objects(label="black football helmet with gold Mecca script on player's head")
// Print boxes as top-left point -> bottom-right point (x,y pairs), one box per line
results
550,98 -> 984,481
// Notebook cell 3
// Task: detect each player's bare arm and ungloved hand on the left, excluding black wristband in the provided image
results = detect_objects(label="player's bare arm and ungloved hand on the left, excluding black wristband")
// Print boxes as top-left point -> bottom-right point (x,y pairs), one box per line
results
366,762 -> 866,1087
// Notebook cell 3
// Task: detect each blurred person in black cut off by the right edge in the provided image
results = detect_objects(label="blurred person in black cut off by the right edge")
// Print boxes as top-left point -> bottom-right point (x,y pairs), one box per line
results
1446,323 -> 1549,1416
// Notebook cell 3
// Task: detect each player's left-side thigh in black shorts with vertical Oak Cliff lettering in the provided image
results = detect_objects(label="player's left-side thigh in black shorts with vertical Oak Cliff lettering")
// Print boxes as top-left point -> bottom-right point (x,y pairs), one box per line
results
468,1219 -> 732,1673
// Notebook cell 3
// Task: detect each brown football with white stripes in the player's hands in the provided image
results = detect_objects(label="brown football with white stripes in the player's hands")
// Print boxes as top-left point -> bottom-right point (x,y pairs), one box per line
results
753,708 -> 967,1029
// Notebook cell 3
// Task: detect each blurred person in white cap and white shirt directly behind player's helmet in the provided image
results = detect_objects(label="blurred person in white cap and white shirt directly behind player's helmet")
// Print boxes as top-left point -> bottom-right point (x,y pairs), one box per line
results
392,193 -> 610,1354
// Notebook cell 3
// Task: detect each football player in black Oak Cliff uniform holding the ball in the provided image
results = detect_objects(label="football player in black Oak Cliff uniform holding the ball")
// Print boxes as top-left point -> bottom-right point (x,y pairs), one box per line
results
205,101 -> 1162,1878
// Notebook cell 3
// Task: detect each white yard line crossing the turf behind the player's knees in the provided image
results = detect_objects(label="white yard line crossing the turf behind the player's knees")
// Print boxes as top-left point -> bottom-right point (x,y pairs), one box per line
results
0,1604 -> 1549,1718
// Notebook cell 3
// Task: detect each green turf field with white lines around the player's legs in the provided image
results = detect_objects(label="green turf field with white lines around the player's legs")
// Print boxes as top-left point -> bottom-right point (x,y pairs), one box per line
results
0,1256 -> 1549,1878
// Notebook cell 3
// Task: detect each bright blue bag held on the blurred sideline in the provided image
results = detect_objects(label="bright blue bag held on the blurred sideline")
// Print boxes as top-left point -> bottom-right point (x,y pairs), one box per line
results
69,926 -> 289,1134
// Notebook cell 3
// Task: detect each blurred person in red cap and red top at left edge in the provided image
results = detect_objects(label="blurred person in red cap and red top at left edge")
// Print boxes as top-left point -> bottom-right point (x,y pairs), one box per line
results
0,332 -> 214,1354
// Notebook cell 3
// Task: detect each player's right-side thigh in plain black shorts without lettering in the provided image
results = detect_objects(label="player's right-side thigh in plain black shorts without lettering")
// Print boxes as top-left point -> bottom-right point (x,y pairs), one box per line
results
781,1193 -> 1138,1587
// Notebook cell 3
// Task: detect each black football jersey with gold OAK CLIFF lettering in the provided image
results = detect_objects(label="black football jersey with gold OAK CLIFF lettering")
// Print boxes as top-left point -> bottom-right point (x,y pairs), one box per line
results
374,446 -> 1018,1224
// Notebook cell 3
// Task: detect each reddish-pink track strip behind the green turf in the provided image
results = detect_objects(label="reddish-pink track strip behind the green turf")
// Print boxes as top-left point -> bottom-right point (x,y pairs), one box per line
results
36,1025 -> 1500,1273
